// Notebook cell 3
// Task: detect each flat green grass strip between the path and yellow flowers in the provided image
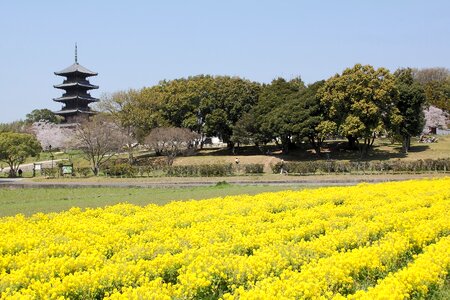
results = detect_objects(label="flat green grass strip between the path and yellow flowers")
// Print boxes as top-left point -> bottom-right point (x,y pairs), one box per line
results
0,184 -> 304,217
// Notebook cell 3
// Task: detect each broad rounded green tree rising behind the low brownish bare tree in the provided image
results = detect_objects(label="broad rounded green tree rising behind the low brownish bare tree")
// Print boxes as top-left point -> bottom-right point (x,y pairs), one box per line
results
154,75 -> 259,148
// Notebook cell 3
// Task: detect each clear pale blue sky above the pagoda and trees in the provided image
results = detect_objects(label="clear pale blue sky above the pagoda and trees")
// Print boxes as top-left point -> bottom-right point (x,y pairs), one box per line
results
0,0 -> 450,122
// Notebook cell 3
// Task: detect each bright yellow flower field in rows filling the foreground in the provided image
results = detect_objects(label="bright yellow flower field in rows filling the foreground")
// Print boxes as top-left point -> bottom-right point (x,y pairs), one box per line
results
0,178 -> 450,299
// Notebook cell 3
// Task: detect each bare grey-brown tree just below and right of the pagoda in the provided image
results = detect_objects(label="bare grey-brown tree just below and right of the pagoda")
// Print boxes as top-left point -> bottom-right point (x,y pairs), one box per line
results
73,115 -> 126,175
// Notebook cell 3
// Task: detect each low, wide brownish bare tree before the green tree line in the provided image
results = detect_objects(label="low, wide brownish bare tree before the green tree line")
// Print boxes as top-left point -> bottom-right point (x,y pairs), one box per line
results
145,127 -> 200,166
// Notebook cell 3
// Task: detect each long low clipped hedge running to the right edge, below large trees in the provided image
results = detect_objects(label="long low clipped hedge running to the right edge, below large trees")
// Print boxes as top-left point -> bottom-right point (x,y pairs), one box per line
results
272,158 -> 450,174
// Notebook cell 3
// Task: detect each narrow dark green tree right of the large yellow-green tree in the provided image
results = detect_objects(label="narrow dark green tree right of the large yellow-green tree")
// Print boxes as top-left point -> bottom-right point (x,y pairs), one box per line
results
392,68 -> 426,153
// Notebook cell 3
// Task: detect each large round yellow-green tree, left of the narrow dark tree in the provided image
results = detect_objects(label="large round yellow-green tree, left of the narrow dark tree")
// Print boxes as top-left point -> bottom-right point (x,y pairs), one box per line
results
319,64 -> 401,155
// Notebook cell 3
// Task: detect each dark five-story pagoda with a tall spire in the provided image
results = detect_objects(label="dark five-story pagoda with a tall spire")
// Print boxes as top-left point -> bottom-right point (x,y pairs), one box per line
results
53,45 -> 99,123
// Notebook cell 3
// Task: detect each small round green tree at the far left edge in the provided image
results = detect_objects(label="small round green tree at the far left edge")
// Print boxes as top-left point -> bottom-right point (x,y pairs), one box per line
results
0,132 -> 42,177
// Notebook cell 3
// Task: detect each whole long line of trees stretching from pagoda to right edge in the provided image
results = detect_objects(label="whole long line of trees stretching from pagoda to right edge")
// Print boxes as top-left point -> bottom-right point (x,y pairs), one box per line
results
99,64 -> 450,155
